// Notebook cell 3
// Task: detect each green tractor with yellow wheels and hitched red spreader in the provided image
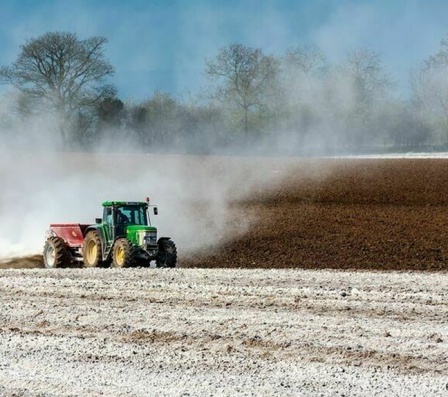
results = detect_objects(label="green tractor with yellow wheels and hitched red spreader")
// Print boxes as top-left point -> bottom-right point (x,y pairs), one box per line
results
43,199 -> 177,268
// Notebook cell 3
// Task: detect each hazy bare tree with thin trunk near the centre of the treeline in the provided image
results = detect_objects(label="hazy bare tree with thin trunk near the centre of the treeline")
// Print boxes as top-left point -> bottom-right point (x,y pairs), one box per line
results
206,44 -> 279,139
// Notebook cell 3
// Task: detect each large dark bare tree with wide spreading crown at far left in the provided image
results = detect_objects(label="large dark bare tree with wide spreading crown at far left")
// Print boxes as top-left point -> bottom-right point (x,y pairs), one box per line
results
0,32 -> 115,144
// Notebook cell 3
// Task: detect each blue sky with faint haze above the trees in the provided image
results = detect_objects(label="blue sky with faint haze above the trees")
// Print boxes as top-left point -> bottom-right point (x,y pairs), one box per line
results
0,0 -> 448,101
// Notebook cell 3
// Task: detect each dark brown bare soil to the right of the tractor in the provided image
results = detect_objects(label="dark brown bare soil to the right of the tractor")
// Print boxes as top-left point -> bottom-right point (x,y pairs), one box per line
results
182,159 -> 448,271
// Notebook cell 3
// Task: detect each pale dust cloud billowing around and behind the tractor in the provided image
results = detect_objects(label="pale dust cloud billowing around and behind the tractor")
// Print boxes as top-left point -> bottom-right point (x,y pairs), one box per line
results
0,145 -> 300,260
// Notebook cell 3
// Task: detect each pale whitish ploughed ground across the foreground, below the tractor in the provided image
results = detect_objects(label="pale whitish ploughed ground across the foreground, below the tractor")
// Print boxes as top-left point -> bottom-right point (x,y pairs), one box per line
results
0,269 -> 448,397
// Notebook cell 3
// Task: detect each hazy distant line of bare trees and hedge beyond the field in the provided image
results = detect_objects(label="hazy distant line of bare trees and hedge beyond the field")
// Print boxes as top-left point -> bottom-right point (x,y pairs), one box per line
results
0,32 -> 448,155
